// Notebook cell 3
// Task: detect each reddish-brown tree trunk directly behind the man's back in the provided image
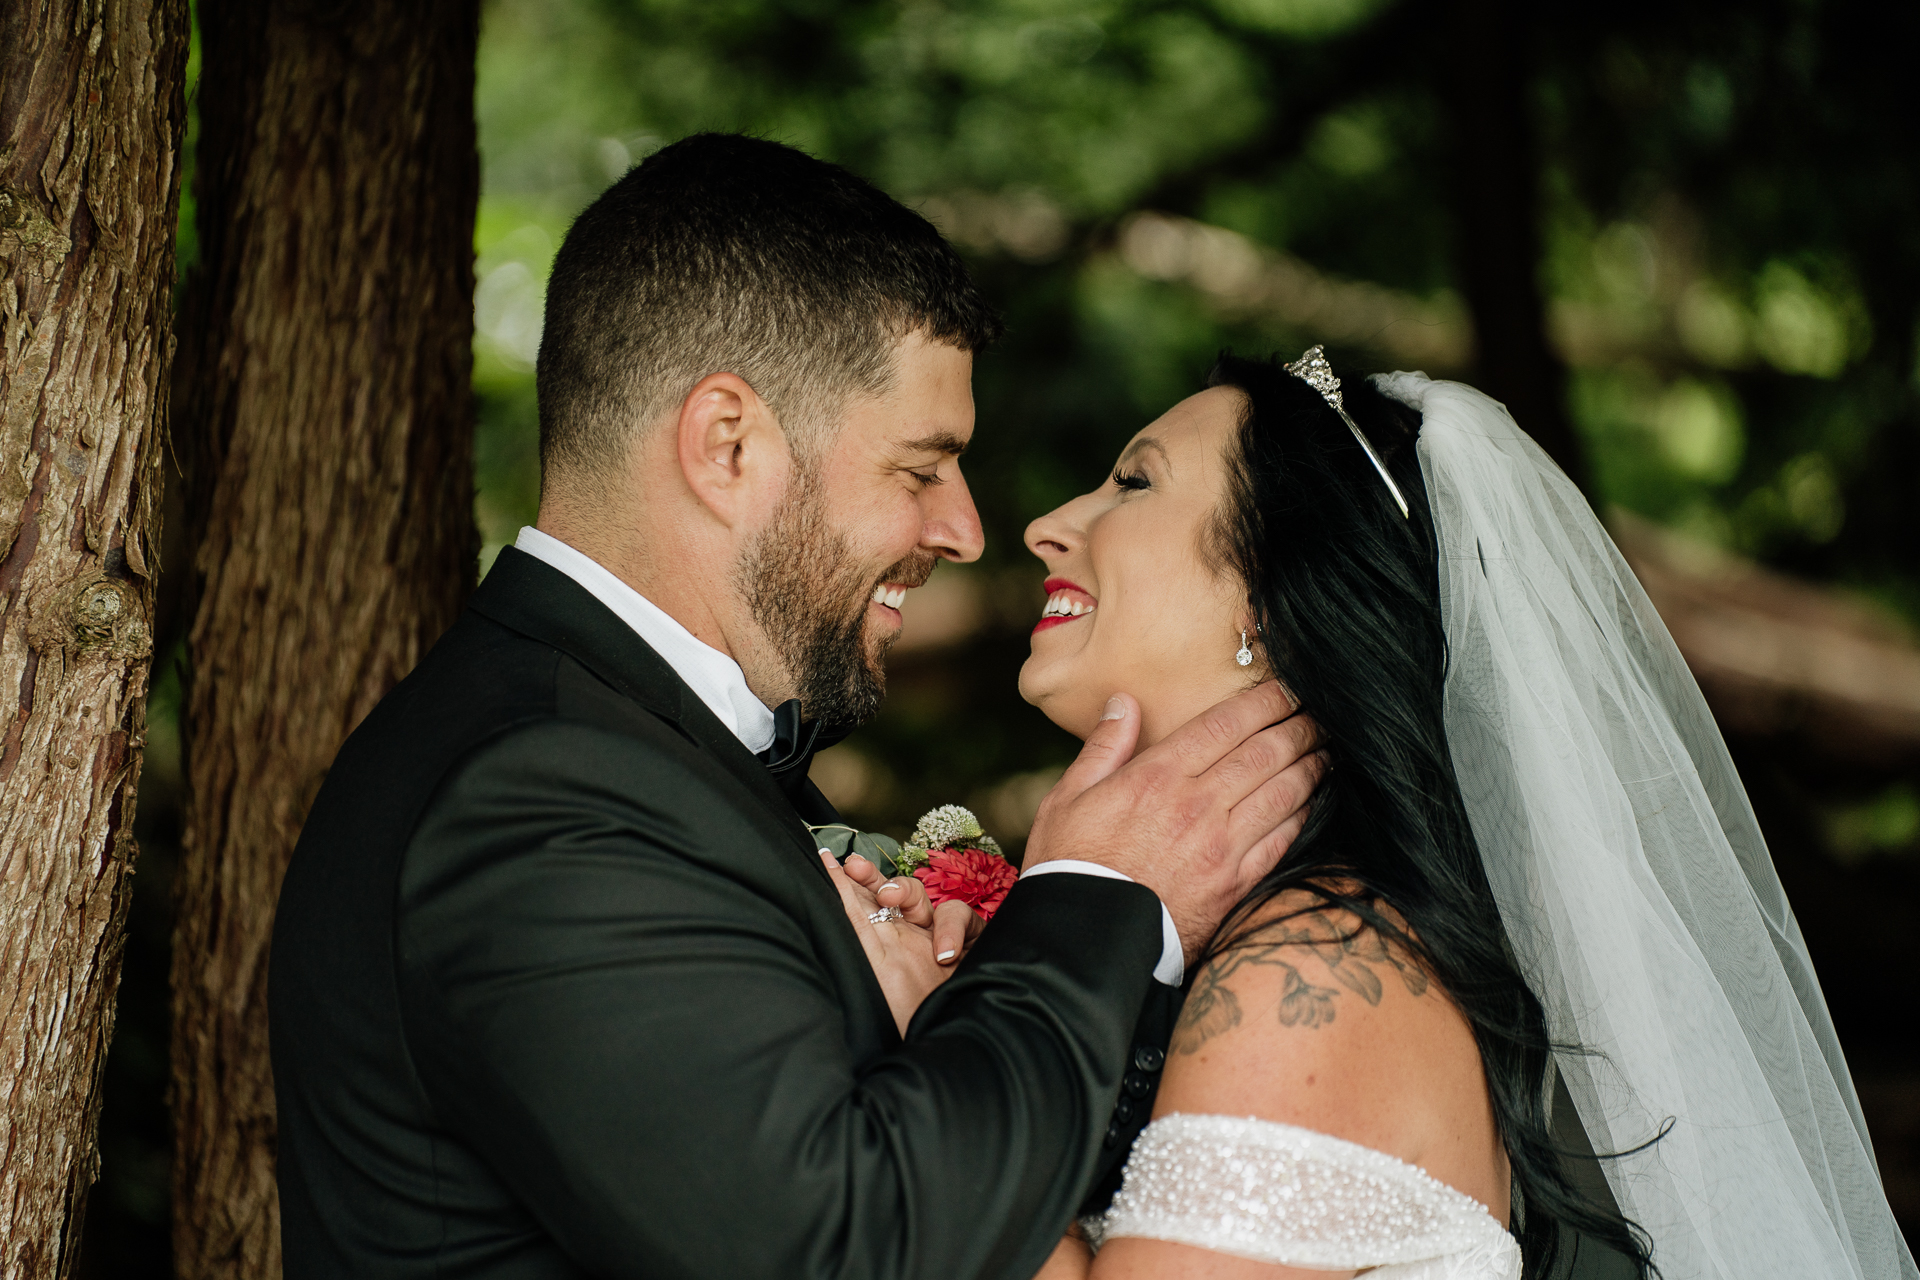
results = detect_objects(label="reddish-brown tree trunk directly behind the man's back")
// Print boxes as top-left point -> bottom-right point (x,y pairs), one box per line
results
173,0 -> 480,1280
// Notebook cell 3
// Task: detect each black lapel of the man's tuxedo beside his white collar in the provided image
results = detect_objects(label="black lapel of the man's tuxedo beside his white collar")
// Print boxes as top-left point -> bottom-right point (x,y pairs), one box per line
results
468,547 -> 826,867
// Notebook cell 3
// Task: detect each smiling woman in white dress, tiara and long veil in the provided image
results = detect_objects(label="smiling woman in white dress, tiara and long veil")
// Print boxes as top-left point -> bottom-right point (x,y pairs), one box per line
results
833,347 -> 1920,1280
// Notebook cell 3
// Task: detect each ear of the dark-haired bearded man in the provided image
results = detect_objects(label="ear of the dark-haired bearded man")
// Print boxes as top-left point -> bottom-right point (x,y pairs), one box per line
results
674,372 -> 793,528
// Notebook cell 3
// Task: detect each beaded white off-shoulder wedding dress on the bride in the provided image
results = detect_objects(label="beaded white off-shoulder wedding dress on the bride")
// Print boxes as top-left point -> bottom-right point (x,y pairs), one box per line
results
1096,1113 -> 1521,1280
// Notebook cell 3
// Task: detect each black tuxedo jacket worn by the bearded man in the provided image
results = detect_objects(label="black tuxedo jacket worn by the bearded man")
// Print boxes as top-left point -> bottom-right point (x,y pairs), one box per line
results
271,549 -> 1167,1280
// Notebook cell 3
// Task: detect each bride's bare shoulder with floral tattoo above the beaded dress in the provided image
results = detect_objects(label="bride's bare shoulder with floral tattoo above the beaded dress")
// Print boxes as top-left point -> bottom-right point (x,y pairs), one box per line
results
1154,890 -> 1492,1163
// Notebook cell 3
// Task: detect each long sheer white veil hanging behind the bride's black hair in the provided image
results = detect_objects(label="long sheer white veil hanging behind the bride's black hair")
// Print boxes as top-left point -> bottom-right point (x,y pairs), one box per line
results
1377,374 -> 1920,1280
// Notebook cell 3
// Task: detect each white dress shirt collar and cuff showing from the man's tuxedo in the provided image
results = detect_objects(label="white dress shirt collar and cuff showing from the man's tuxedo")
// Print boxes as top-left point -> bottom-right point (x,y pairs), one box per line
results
513,526 -> 1187,986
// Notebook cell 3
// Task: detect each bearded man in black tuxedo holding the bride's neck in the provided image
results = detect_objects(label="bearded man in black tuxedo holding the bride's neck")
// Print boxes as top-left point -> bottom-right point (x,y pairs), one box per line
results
271,136 -> 1317,1280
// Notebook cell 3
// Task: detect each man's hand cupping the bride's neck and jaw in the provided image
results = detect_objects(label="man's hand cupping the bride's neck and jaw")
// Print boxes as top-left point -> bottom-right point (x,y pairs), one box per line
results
1025,681 -> 1327,963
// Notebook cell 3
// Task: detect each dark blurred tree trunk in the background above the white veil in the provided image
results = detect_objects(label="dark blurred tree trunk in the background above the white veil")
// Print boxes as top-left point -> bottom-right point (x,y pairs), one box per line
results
1440,0 -> 1588,487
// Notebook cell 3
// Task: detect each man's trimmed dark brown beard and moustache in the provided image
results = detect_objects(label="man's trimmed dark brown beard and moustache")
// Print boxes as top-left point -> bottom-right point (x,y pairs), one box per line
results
735,468 -> 935,725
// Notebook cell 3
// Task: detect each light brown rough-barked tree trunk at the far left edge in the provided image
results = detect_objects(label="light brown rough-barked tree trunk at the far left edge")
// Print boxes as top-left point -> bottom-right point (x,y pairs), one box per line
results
0,0 -> 188,1280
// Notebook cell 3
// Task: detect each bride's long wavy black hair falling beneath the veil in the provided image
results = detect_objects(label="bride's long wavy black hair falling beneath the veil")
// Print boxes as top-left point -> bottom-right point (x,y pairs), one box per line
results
1208,355 -> 1657,1280
